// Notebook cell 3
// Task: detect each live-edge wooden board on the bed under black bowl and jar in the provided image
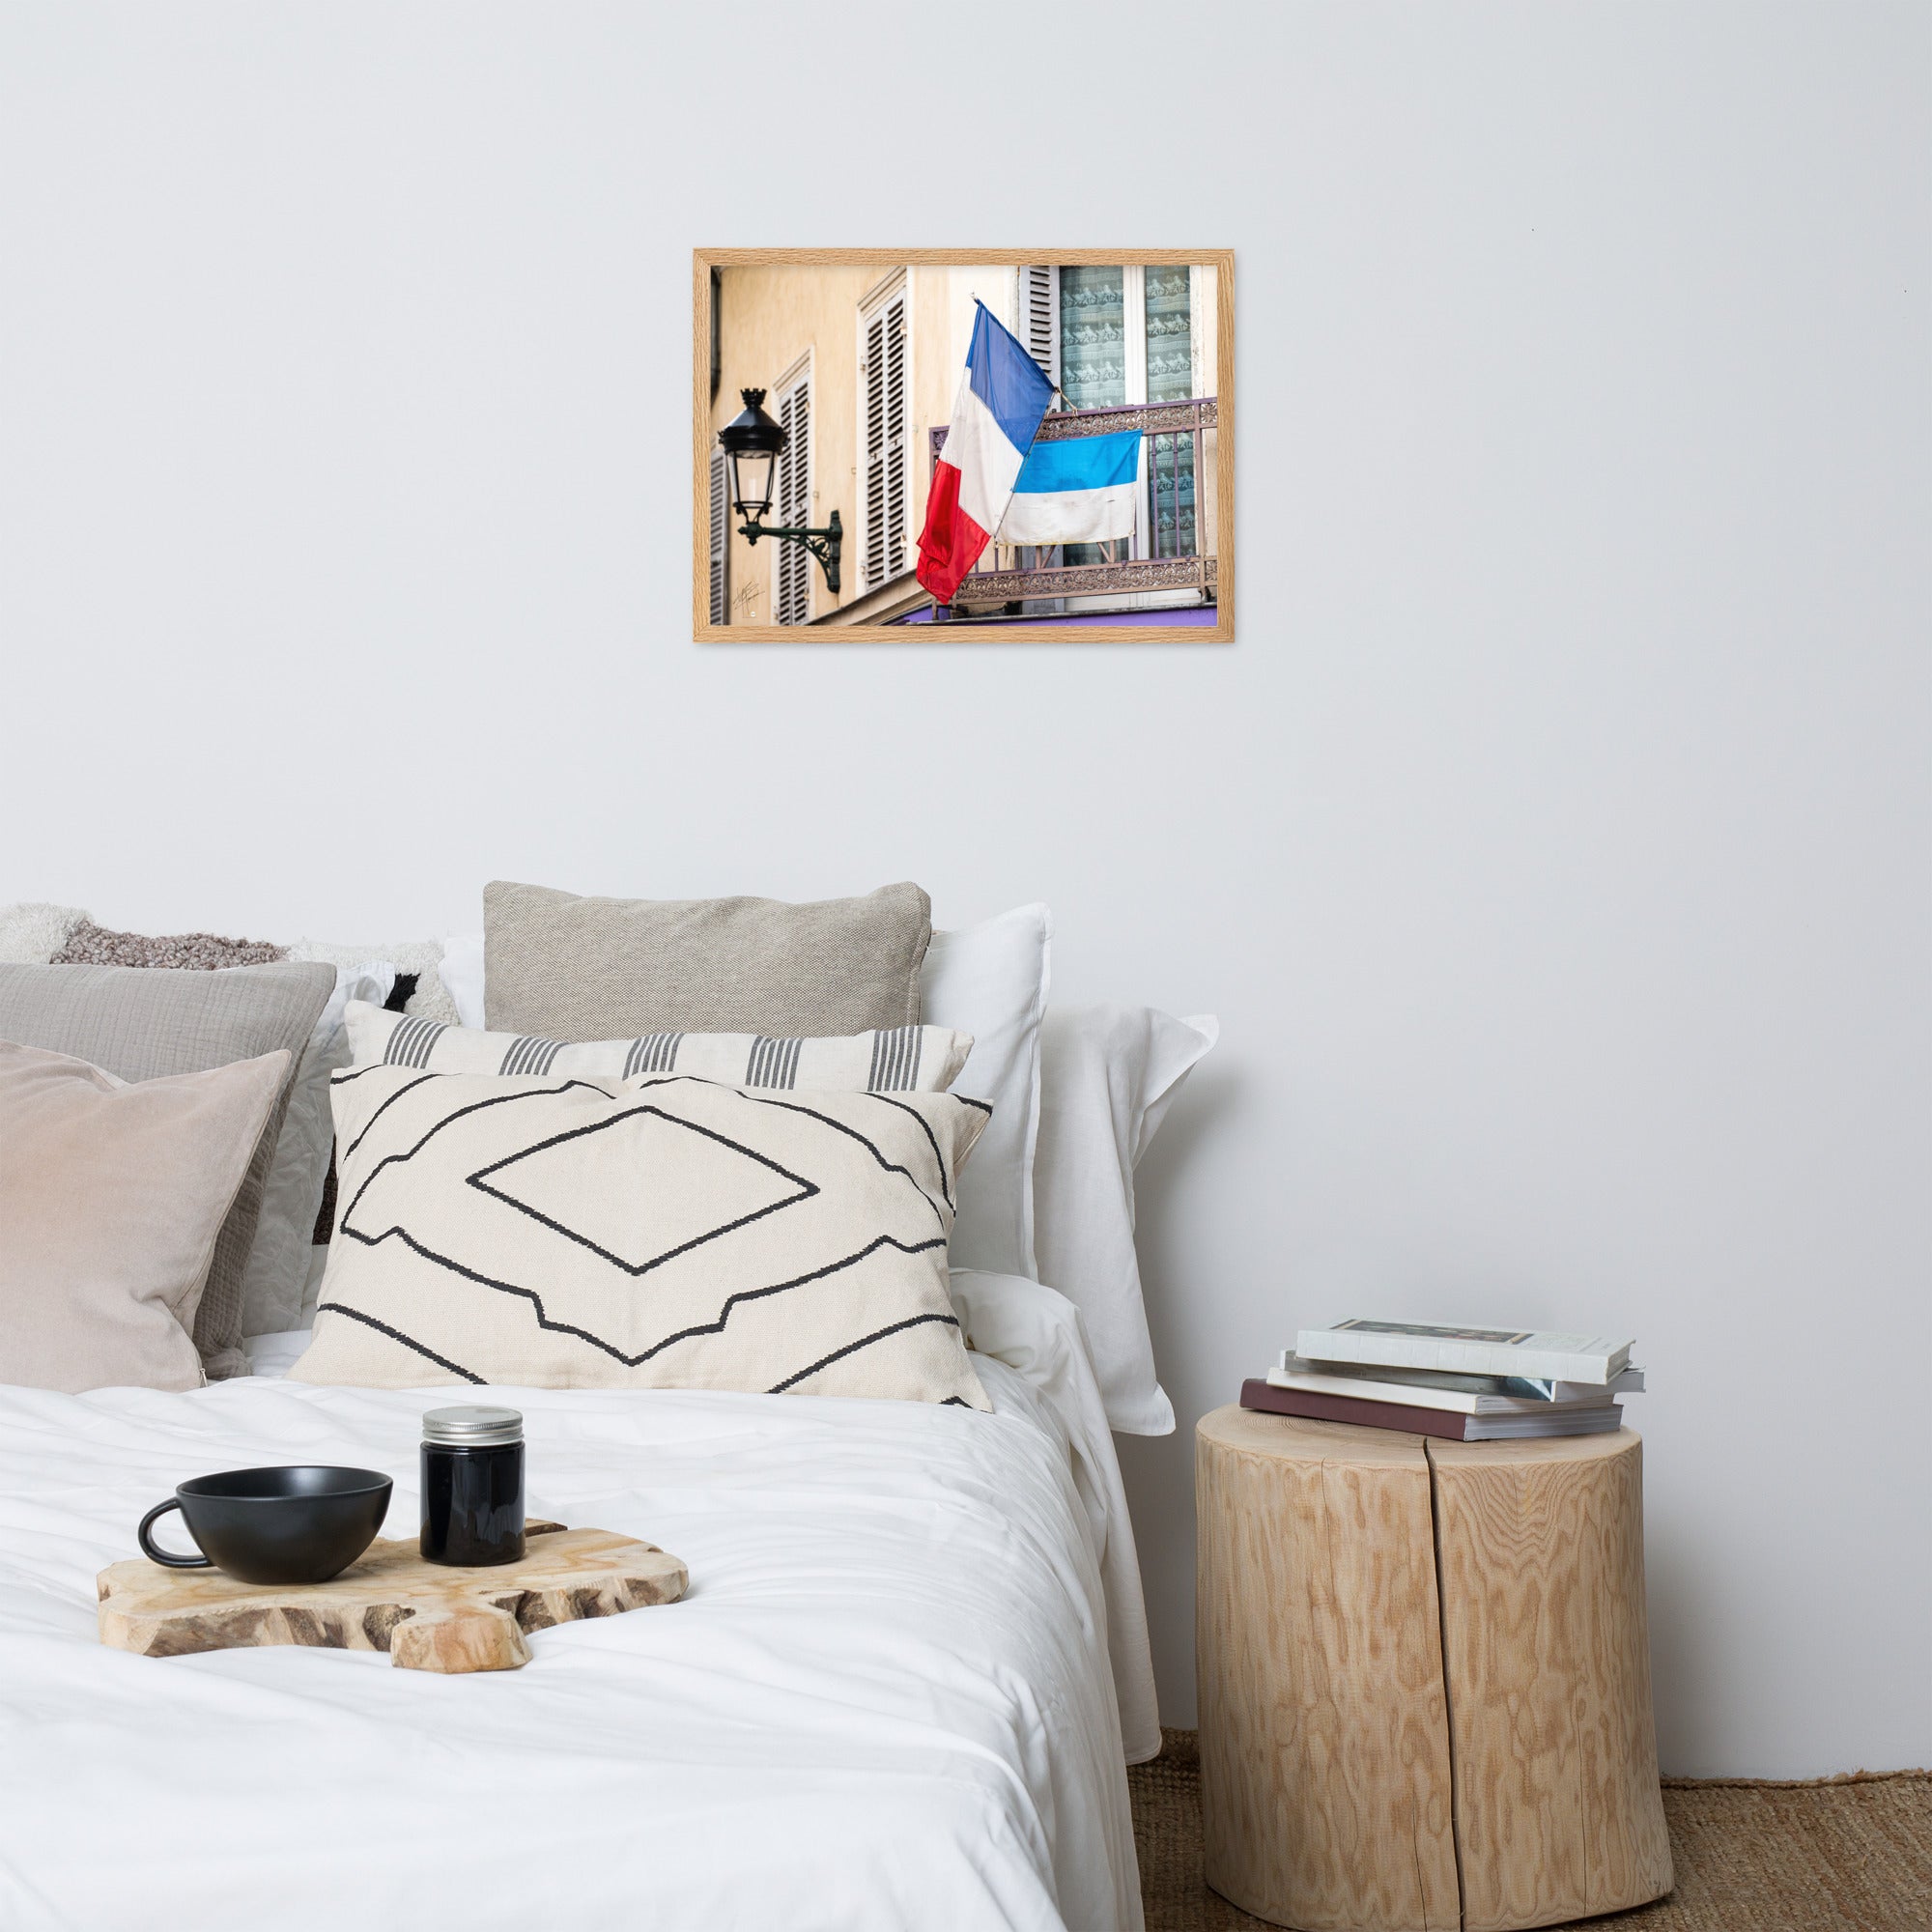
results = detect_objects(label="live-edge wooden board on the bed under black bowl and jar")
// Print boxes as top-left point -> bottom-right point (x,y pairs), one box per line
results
99,1524 -> 690,1673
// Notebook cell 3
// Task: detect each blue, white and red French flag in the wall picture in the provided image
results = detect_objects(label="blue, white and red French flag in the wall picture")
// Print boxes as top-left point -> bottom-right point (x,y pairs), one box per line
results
918,301 -> 1053,603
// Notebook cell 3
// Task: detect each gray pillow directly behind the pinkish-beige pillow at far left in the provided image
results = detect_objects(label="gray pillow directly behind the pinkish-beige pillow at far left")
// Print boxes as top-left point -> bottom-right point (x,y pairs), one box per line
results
0,962 -> 336,1381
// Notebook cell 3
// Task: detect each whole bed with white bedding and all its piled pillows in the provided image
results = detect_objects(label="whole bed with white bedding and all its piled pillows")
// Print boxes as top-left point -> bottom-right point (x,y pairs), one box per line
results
0,883 -> 1213,1932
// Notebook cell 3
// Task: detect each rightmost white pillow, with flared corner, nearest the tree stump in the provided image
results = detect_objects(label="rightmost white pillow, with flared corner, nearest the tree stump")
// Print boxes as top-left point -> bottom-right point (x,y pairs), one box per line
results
1036,1007 -> 1221,1435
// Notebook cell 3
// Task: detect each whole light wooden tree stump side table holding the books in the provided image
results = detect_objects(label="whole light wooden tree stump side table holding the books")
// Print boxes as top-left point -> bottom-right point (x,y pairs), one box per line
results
1194,1408 -> 1671,1932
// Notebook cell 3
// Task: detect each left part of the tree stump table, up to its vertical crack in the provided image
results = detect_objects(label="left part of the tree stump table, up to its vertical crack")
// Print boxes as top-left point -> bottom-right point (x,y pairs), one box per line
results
1194,1408 -> 1463,1932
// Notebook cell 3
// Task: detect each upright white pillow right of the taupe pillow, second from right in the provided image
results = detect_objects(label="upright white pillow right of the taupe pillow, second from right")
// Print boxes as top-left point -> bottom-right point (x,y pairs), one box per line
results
920,906 -> 1053,1281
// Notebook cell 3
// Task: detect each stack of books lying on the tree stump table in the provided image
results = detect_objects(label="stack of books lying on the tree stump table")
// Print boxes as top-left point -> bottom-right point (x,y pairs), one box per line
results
1240,1321 -> 1644,1443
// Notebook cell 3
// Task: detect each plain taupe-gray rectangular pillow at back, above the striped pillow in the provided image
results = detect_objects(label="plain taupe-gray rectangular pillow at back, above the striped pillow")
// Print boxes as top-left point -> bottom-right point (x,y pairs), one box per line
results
483,881 -> 933,1039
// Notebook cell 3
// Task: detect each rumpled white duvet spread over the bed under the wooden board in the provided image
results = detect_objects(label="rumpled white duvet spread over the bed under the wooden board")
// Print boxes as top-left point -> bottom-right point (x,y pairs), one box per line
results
0,1277 -> 1157,1932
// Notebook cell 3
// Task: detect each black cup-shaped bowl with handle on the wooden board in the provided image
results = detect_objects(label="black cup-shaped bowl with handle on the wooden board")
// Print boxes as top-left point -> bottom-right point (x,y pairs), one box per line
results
139,1464 -> 394,1582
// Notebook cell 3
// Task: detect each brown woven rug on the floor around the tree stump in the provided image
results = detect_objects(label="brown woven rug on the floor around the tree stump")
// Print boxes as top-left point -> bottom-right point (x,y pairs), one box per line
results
1126,1731 -> 1932,1932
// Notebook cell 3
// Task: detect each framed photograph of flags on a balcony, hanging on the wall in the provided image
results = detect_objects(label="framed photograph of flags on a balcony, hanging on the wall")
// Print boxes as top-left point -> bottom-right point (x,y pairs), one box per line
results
692,249 -> 1235,643
